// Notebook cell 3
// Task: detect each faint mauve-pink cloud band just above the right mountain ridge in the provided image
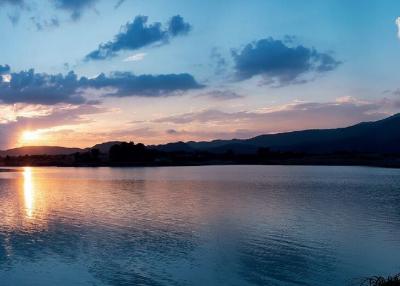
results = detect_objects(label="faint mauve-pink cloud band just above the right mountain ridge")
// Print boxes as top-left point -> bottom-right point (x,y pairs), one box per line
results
153,98 -> 388,134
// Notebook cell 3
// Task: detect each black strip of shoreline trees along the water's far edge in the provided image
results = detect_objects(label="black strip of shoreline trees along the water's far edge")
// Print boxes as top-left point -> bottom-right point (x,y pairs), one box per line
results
0,142 -> 400,167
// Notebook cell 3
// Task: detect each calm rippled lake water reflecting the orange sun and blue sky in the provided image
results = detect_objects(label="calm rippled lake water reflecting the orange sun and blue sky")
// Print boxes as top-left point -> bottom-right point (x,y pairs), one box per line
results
0,166 -> 400,286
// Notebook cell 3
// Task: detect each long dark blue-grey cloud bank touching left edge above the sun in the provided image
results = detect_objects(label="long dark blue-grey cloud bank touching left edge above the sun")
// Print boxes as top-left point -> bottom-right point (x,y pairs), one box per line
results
0,66 -> 202,105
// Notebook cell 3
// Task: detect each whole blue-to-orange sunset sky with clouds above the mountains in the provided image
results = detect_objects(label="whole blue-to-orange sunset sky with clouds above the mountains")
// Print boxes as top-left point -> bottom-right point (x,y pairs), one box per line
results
0,0 -> 400,149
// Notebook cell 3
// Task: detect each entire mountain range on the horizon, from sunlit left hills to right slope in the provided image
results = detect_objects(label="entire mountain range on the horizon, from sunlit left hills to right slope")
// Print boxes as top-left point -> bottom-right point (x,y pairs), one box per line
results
0,113 -> 400,157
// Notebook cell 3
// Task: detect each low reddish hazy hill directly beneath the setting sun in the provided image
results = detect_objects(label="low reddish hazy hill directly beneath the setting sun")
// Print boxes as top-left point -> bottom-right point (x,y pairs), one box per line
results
0,146 -> 84,157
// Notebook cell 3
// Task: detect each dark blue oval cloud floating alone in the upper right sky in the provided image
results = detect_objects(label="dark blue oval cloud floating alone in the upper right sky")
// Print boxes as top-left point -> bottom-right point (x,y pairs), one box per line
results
232,38 -> 341,86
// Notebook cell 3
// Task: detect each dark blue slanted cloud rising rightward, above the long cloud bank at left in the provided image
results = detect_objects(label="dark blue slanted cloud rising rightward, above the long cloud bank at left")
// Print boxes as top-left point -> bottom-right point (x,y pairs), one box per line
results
85,15 -> 191,61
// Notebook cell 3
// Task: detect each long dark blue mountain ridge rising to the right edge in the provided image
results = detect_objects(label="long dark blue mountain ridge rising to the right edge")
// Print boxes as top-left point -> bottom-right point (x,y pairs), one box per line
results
155,114 -> 400,154
